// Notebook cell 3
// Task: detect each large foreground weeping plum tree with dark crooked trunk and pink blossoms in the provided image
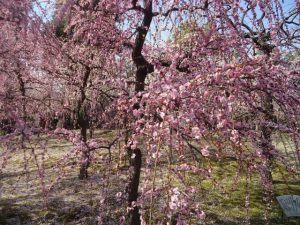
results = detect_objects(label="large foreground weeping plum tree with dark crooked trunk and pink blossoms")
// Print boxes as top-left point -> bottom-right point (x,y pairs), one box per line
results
57,0 -> 299,224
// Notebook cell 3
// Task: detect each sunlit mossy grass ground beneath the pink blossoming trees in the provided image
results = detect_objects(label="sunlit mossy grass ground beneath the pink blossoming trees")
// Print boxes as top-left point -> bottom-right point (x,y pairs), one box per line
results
0,132 -> 300,225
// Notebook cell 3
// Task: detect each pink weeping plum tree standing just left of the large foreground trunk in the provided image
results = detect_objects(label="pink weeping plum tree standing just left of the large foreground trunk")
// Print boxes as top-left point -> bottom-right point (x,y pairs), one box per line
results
54,1 -> 122,179
